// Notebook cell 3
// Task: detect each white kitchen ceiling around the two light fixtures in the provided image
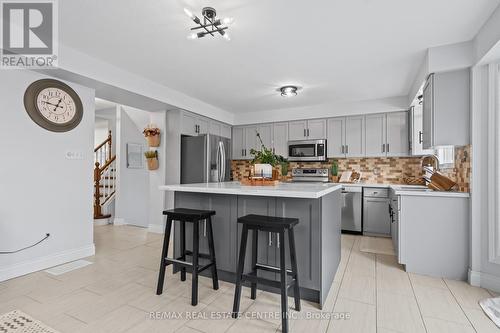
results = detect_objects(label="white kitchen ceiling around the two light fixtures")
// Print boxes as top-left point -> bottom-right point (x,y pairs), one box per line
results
59,0 -> 500,113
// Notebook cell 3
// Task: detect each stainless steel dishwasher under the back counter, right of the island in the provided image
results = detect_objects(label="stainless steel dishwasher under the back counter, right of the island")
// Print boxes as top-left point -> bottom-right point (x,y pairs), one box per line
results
342,186 -> 363,234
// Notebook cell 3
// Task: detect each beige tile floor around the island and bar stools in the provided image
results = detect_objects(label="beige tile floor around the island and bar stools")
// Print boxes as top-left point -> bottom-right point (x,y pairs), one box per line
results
0,226 -> 500,333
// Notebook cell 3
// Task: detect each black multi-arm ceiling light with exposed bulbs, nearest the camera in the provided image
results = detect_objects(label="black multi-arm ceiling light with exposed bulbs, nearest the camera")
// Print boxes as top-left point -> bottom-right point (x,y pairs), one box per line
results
184,7 -> 233,40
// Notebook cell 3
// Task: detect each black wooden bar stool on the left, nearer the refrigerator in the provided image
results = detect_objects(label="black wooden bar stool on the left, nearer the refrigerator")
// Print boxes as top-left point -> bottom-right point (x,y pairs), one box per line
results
156,208 -> 219,306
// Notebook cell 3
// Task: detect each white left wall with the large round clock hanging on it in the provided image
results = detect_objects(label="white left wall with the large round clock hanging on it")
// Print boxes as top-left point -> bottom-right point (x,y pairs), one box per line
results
0,70 -> 94,281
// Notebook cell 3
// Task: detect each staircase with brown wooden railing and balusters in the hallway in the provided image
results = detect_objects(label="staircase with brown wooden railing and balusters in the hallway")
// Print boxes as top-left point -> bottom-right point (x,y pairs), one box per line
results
94,131 -> 116,220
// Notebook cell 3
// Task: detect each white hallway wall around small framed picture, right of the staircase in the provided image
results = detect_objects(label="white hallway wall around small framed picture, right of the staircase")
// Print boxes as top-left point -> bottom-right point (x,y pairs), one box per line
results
114,106 -> 149,227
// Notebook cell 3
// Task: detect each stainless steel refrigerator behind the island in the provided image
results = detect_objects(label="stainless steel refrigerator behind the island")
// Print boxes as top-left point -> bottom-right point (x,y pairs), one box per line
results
181,134 -> 231,184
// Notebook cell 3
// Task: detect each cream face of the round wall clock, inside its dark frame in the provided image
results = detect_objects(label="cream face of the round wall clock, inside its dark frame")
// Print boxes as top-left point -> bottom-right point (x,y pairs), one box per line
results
36,88 -> 76,124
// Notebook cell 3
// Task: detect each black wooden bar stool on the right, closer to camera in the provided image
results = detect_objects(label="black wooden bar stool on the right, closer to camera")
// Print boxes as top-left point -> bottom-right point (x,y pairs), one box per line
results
232,215 -> 300,333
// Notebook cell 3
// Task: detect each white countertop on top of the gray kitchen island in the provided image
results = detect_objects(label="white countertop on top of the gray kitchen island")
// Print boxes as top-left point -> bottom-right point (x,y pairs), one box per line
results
160,182 -> 342,199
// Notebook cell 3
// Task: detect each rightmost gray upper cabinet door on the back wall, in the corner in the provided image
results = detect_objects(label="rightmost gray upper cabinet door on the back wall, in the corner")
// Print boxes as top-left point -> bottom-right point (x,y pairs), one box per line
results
385,111 -> 410,156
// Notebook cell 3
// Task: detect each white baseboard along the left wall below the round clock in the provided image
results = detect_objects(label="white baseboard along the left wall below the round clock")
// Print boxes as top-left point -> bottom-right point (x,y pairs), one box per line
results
0,244 -> 95,282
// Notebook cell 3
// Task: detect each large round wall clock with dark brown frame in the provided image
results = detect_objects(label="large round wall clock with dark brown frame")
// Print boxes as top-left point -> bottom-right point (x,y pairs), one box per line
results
24,79 -> 83,132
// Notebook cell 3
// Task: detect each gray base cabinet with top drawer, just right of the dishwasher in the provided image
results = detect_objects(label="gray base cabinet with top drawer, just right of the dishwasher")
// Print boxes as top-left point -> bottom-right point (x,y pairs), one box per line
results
363,187 -> 391,237
